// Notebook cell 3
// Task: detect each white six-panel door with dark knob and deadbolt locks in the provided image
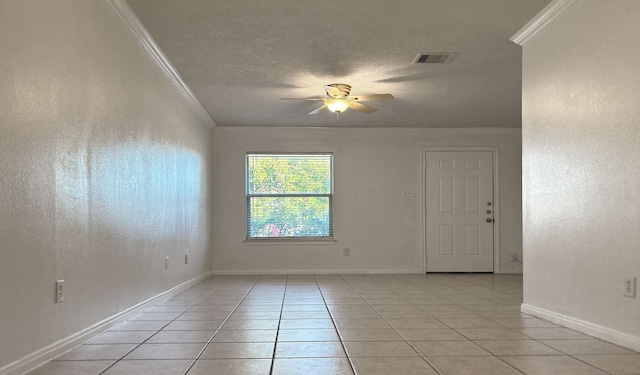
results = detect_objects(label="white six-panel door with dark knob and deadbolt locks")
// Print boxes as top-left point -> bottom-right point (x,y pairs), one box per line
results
425,151 -> 494,272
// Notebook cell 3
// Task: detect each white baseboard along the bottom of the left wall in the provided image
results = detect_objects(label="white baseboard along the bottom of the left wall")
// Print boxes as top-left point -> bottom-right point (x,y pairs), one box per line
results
0,272 -> 211,375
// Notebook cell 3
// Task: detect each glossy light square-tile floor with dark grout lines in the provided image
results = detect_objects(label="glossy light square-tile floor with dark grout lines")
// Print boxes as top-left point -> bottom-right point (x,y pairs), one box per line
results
29,274 -> 640,375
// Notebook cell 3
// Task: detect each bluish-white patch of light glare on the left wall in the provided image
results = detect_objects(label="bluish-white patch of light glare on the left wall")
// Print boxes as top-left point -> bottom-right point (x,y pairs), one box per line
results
55,142 -> 203,242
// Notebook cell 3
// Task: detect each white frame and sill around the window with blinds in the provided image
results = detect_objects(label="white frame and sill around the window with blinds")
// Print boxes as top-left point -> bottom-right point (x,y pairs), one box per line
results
243,151 -> 335,245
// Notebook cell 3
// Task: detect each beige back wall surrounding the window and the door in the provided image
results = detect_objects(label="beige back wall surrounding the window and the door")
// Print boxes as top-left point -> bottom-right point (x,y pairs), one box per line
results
213,126 -> 522,273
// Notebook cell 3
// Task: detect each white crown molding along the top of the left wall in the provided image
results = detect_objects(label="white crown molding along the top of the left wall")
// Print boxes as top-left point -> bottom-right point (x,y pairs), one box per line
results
105,0 -> 216,129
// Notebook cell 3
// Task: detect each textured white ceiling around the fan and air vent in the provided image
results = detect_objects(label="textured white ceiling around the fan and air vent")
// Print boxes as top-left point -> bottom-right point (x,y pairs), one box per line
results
128,0 -> 549,128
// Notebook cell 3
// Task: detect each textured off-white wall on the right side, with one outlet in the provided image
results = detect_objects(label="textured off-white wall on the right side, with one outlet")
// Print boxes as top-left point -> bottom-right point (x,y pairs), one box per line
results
522,0 -> 640,350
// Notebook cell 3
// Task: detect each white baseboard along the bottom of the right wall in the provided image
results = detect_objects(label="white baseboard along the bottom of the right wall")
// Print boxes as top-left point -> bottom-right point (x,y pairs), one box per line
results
520,303 -> 640,351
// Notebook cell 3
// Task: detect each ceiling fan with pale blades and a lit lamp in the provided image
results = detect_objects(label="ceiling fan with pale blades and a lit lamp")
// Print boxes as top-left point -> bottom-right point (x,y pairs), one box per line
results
282,83 -> 393,115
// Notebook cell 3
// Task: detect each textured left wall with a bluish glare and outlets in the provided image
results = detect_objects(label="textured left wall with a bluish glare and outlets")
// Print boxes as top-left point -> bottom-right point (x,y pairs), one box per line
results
0,0 -> 211,372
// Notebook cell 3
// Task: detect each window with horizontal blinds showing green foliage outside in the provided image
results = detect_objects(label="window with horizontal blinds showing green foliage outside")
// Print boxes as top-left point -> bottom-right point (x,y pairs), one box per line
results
246,153 -> 333,239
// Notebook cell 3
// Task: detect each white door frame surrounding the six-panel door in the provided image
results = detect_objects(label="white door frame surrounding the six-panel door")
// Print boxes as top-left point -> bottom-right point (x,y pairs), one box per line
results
420,146 -> 500,274
